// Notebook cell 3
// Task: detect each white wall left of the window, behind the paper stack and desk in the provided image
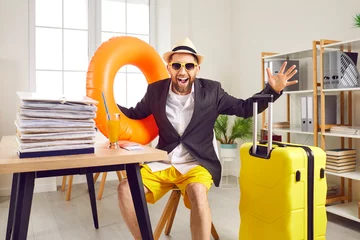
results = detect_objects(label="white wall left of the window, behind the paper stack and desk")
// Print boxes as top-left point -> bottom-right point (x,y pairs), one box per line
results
0,0 -> 56,196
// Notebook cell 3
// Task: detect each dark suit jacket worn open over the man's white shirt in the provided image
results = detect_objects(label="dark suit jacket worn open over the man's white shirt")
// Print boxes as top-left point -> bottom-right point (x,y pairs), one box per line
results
119,78 -> 281,186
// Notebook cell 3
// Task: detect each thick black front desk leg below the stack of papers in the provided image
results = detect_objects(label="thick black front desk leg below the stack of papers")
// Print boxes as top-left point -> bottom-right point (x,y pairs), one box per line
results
12,172 -> 35,240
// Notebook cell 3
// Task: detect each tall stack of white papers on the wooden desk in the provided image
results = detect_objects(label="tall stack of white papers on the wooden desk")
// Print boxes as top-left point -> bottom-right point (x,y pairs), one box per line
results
15,93 -> 97,158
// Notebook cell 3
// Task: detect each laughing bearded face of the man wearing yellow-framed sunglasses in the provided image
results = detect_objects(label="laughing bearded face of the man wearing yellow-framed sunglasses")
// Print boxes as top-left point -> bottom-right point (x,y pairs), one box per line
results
167,53 -> 200,95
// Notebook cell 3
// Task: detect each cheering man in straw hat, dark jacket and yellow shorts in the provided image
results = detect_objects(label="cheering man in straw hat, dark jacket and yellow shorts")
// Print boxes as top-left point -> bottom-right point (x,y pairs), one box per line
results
118,38 -> 296,240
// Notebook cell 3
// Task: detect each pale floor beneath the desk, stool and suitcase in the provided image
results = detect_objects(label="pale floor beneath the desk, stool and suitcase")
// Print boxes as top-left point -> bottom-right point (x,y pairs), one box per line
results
0,178 -> 360,240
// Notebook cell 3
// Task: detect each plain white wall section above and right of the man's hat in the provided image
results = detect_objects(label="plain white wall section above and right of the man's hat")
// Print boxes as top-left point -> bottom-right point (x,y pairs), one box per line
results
171,0 -> 233,90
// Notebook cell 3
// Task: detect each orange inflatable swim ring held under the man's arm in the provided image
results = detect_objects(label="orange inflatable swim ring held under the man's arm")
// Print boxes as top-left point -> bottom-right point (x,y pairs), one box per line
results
86,36 -> 169,144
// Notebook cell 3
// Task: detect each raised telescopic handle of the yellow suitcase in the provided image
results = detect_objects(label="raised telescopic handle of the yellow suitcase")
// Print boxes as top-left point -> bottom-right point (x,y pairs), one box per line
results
252,94 -> 274,156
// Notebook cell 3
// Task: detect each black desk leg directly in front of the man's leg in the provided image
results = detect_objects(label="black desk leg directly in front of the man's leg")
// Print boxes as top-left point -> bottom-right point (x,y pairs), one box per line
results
126,163 -> 154,240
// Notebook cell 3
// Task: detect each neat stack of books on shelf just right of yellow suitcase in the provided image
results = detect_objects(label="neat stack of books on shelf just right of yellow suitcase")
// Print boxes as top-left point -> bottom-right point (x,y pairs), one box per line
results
326,148 -> 356,173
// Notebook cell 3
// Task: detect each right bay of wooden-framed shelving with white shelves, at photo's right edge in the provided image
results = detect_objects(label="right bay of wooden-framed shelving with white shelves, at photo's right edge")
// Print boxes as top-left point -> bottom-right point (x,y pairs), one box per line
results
320,39 -> 360,222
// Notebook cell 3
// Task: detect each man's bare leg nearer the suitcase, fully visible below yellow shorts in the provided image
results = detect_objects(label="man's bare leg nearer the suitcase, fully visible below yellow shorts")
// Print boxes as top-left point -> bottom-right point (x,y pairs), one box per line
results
186,183 -> 211,240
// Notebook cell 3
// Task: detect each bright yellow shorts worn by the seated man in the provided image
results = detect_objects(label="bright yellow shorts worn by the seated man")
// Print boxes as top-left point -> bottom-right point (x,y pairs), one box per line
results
140,164 -> 213,209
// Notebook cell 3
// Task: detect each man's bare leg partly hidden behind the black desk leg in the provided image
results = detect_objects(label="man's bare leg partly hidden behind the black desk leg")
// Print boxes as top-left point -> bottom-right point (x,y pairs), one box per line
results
118,178 -> 149,240
